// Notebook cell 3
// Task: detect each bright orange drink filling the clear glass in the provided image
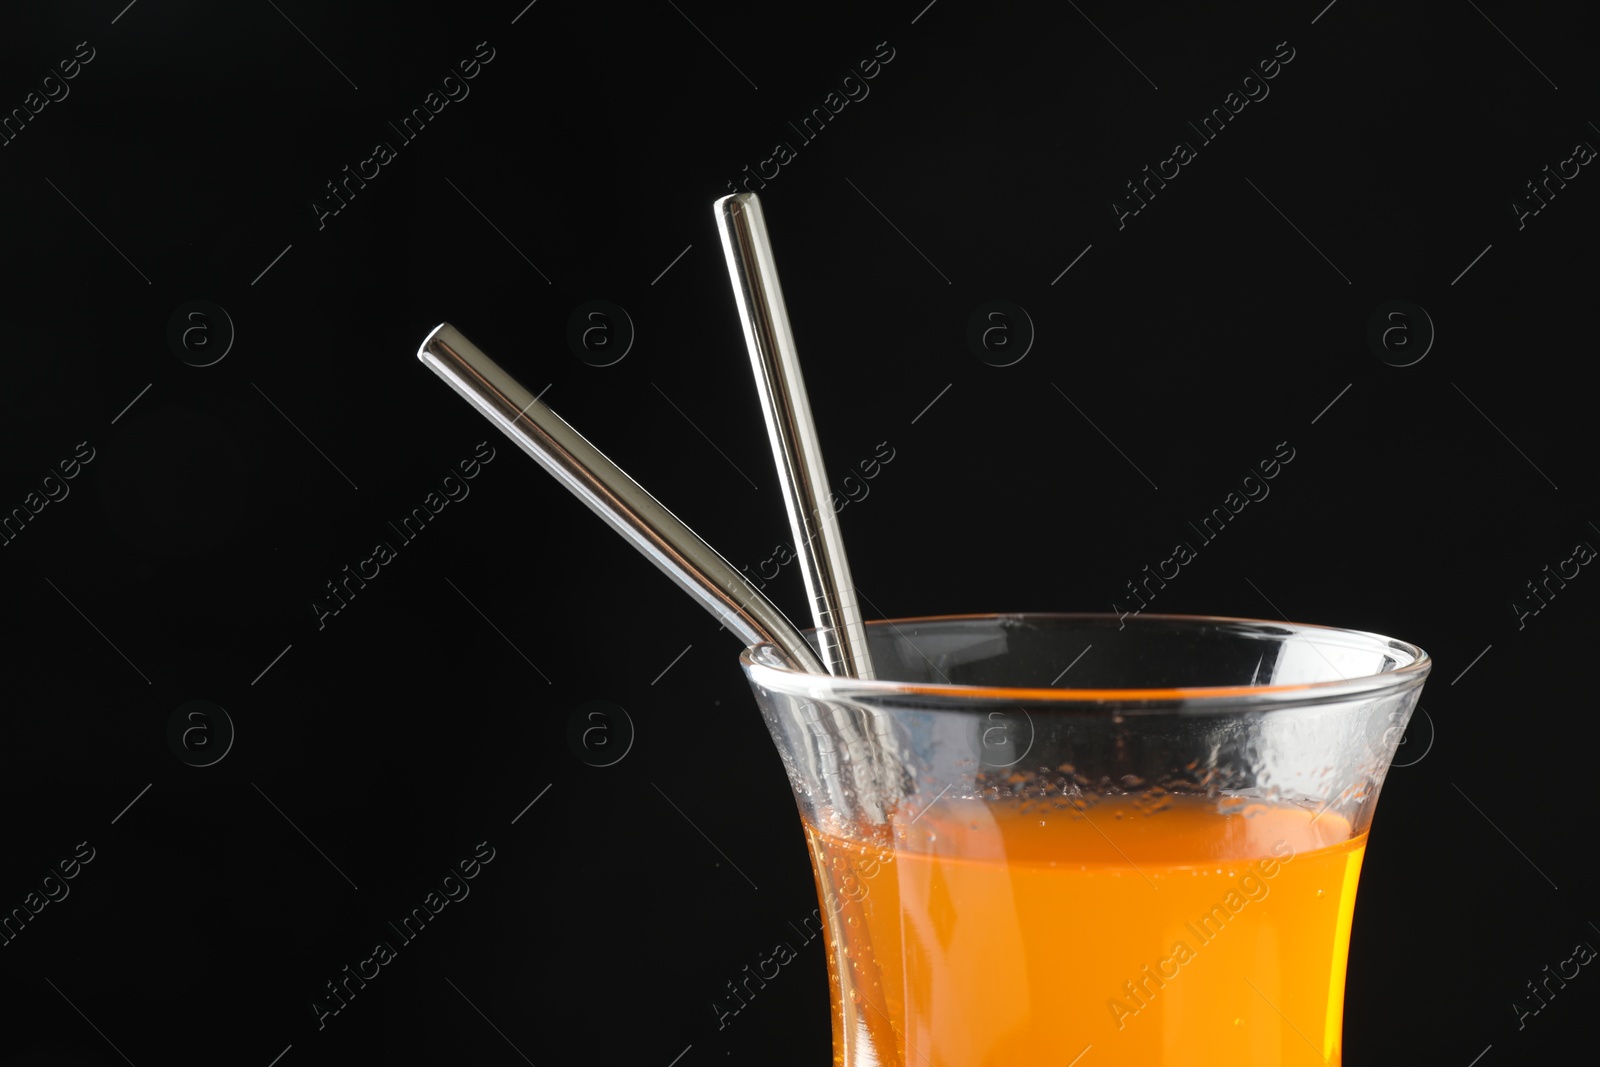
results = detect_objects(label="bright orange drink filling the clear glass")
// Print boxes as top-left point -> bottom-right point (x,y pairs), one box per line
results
806,797 -> 1366,1067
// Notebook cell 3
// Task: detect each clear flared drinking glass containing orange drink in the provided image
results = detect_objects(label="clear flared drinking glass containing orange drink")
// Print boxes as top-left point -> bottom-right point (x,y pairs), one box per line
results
741,614 -> 1432,1067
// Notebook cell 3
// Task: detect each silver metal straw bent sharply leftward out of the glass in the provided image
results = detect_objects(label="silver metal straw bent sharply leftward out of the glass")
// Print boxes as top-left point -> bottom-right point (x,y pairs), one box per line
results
416,323 -> 824,673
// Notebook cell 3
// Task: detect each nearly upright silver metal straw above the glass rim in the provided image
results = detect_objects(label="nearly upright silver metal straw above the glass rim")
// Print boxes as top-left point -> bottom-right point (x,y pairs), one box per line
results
715,192 -> 874,678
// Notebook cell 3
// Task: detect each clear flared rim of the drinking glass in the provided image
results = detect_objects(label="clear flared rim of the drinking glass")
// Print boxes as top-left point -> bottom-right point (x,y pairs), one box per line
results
739,611 -> 1434,712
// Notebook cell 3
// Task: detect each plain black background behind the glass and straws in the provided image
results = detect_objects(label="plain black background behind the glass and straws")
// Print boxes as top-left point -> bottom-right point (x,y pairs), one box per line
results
0,0 -> 1600,1067
